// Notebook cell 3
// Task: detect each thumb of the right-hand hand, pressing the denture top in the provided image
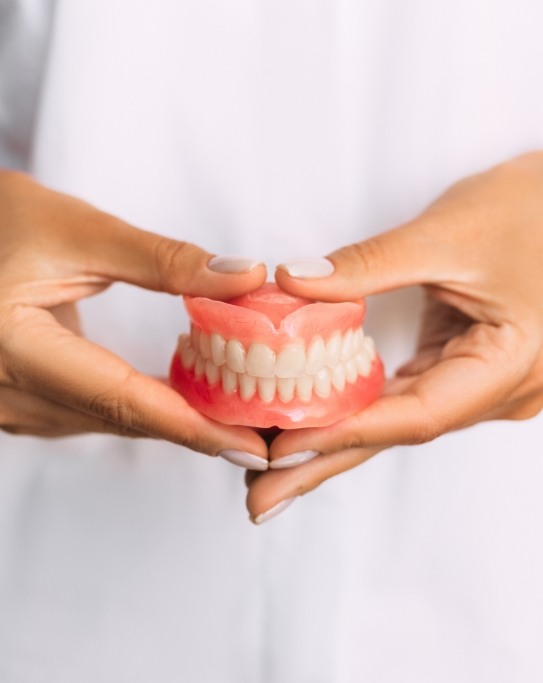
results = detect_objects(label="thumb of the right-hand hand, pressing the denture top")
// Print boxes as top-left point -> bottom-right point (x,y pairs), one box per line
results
276,218 -> 452,302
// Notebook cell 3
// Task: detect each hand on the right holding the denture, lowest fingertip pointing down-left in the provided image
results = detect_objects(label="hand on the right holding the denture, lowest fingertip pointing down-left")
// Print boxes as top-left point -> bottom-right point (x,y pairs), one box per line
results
248,153 -> 543,519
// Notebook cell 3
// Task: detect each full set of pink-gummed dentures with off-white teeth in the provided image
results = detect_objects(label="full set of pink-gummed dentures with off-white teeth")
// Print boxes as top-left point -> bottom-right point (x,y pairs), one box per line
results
170,283 -> 384,429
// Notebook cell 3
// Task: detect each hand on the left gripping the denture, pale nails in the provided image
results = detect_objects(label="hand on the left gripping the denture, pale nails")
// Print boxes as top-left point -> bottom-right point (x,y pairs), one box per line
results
0,171 -> 267,458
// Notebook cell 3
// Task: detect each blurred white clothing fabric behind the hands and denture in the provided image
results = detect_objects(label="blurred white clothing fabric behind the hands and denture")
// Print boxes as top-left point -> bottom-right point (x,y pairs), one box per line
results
0,0 -> 543,683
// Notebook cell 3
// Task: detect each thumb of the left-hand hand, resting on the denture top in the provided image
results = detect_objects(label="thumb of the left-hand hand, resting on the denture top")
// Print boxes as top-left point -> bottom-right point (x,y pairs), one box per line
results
86,216 -> 266,299
